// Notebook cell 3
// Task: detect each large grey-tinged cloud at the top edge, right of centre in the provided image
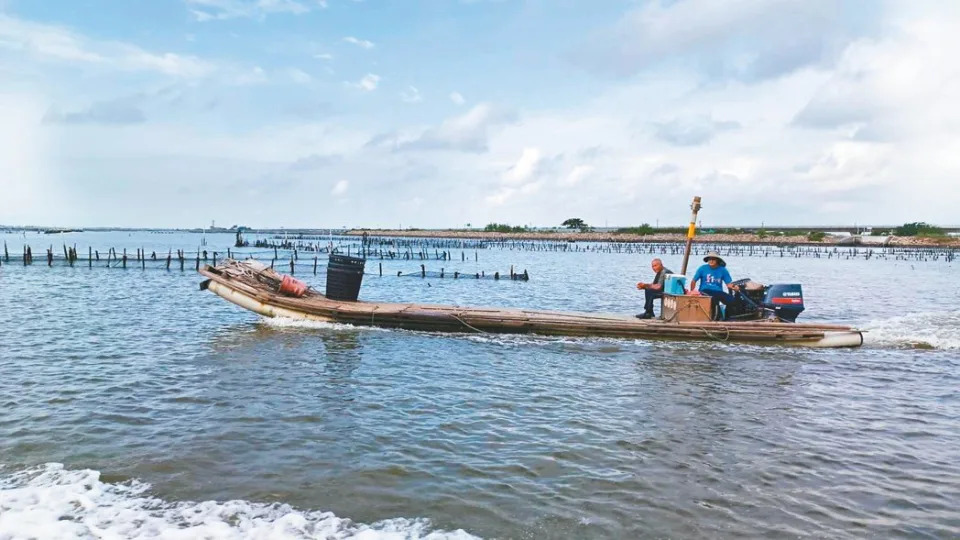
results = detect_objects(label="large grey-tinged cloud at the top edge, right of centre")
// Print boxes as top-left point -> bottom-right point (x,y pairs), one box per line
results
571,0 -> 879,81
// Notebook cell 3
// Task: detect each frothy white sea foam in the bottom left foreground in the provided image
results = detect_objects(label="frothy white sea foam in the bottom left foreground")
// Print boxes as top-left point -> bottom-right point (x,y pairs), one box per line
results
0,463 -> 476,540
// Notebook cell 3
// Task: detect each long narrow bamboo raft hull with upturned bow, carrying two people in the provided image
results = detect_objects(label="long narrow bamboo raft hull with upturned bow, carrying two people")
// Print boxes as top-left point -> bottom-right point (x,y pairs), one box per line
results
200,259 -> 863,347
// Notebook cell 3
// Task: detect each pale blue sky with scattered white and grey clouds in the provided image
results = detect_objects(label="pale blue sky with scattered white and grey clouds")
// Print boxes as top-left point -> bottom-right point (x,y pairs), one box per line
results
0,0 -> 960,228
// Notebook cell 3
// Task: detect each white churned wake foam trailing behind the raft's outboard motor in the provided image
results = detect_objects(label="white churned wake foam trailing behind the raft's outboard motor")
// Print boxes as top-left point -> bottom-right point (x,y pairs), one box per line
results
863,311 -> 960,351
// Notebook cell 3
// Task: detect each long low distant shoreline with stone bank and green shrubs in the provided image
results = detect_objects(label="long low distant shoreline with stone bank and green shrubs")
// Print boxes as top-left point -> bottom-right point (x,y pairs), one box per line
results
345,229 -> 960,248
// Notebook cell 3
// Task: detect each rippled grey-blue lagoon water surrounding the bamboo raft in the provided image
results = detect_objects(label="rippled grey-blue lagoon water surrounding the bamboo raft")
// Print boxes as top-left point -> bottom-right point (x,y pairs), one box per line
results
0,232 -> 960,539
